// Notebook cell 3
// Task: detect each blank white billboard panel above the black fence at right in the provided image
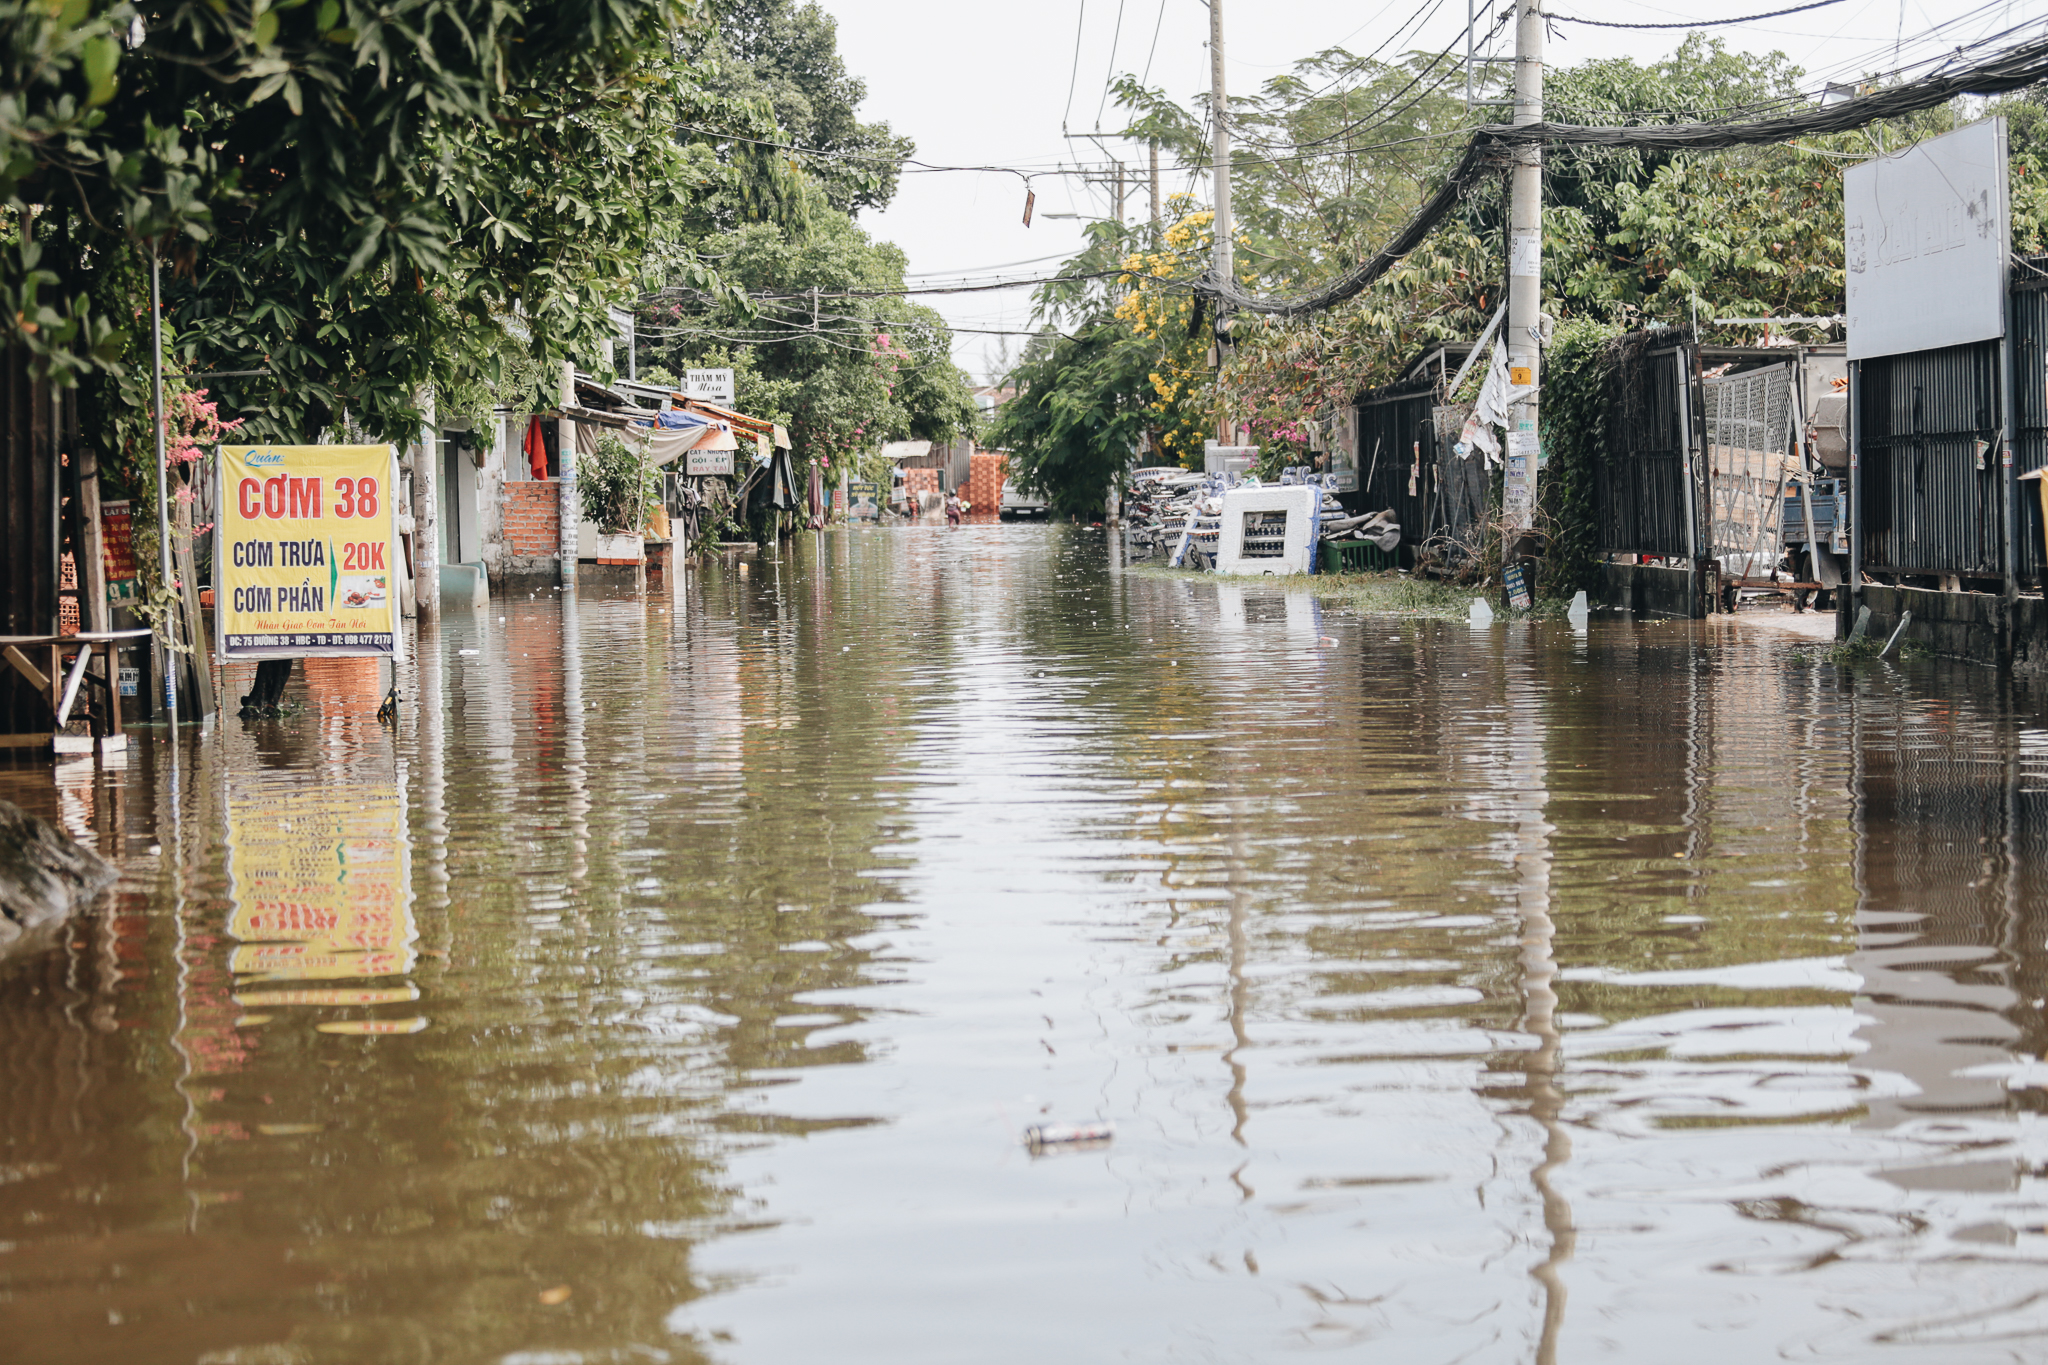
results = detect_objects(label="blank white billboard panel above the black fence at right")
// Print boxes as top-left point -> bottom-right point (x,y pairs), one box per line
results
1841,119 -> 2011,360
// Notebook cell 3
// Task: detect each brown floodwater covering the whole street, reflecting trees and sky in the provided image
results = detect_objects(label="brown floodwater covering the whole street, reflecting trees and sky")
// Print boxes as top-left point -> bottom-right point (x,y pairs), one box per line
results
0,526 -> 2048,1365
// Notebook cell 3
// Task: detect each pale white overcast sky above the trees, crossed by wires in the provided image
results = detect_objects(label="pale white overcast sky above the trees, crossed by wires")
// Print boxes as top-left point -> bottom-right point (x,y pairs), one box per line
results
819,0 -> 2048,381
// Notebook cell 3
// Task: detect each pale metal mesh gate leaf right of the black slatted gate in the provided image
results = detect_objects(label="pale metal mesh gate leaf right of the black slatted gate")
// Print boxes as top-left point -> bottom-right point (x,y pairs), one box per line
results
1700,362 -> 1798,577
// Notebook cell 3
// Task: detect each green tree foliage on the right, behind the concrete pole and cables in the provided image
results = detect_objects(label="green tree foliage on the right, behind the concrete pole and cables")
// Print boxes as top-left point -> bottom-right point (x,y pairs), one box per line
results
1003,35 -> 2048,497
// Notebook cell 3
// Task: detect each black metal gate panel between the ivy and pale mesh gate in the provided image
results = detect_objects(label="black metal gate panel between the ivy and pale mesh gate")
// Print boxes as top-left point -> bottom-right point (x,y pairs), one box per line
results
1593,334 -> 1706,559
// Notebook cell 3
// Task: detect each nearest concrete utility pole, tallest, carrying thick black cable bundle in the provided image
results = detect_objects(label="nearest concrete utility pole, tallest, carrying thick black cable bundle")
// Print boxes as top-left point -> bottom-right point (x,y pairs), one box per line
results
1501,0 -> 1542,544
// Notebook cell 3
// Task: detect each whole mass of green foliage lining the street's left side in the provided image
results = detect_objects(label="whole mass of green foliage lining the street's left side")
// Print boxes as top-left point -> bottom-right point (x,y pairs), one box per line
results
0,0 -> 971,485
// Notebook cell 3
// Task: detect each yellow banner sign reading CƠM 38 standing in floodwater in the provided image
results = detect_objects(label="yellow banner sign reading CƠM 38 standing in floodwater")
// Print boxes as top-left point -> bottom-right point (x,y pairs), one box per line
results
213,446 -> 403,659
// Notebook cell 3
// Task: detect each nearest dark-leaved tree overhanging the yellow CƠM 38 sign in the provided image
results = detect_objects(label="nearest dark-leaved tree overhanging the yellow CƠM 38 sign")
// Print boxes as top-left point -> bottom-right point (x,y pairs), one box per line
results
0,0 -> 799,458
